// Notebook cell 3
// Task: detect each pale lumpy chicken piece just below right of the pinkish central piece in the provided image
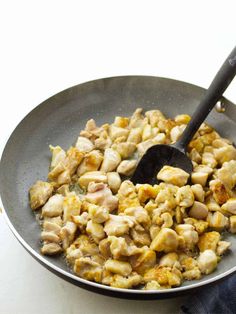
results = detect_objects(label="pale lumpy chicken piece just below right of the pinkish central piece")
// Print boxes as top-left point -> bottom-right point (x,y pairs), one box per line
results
104,214 -> 135,236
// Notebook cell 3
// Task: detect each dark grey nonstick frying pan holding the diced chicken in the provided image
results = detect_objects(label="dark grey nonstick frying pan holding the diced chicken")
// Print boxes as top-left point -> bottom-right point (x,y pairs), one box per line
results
0,76 -> 236,299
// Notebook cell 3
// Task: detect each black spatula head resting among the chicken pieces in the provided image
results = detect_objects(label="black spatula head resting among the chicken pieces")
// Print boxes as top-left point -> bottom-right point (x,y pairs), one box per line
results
131,145 -> 193,184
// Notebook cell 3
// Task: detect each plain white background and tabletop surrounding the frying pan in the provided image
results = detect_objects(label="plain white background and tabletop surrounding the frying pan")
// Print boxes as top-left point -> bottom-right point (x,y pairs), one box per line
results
0,0 -> 236,314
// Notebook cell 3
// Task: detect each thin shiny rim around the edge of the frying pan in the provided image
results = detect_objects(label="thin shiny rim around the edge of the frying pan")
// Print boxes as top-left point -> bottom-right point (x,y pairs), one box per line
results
0,75 -> 236,297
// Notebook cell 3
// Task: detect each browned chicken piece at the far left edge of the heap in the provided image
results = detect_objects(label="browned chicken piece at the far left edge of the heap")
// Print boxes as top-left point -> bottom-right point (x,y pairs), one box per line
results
29,181 -> 53,210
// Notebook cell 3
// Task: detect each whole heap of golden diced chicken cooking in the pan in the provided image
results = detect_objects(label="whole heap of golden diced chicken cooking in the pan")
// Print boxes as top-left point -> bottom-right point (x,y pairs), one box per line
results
29,109 -> 236,290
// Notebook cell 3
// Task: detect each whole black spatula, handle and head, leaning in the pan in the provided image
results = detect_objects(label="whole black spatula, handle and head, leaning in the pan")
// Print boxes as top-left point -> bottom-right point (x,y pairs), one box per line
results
131,47 -> 236,184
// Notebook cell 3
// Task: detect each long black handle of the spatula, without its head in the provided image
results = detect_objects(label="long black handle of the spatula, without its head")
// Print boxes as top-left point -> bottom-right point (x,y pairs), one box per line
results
174,47 -> 236,151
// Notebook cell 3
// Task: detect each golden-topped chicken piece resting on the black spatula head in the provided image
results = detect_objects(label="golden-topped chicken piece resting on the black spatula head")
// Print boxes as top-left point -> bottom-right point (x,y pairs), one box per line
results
157,166 -> 189,186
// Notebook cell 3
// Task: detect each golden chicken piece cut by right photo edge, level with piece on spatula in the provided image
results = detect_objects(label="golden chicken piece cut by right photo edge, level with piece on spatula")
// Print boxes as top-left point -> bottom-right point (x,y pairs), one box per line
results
216,160 -> 236,190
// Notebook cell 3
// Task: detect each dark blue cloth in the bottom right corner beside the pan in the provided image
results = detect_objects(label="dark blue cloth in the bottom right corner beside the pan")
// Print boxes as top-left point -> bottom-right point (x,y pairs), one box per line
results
181,274 -> 236,314
